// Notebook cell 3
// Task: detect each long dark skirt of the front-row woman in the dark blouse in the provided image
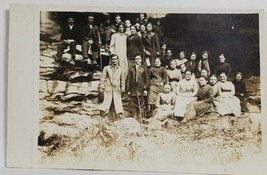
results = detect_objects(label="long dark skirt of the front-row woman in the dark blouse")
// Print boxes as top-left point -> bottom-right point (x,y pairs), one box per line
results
183,101 -> 214,122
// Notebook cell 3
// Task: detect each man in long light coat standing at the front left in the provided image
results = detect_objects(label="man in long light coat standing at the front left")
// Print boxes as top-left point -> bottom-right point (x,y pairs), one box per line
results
99,55 -> 125,119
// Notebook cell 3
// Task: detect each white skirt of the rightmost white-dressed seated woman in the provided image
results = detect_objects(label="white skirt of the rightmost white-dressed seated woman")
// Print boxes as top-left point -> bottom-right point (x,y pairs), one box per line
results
213,96 -> 241,116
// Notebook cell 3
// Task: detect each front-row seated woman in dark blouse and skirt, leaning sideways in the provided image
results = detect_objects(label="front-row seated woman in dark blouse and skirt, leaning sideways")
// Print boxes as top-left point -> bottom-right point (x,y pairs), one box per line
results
182,76 -> 214,123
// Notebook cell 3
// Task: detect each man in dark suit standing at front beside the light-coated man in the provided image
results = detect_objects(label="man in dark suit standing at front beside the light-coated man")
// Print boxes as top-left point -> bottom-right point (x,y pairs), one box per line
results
126,54 -> 149,120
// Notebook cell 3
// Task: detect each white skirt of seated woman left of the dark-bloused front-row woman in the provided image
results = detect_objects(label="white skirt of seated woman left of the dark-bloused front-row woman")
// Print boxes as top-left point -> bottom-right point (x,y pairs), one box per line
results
174,96 -> 197,117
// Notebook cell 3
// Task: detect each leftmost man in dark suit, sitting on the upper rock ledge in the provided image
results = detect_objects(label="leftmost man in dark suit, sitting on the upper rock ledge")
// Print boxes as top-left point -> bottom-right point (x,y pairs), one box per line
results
57,17 -> 80,61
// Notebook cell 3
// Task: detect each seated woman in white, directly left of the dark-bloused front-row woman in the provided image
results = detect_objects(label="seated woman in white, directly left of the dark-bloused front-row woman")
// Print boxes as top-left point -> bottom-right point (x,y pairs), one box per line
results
174,71 -> 198,117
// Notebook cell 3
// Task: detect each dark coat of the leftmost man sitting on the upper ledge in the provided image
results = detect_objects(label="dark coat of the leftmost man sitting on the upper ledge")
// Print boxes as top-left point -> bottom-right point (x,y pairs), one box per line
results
61,24 -> 81,42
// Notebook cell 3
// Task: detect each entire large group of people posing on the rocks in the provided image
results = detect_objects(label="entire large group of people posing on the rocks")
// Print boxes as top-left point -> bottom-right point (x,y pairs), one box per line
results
57,13 -> 249,123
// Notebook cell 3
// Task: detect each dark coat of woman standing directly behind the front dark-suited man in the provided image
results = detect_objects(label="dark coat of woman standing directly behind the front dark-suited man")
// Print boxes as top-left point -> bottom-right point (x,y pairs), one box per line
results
127,34 -> 143,60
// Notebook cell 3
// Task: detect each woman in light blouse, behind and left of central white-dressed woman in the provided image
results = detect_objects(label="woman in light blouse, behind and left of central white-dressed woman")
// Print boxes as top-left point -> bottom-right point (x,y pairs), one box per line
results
167,60 -> 182,91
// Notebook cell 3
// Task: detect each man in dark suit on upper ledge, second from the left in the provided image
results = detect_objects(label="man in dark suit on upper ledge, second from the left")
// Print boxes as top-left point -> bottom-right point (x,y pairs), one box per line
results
82,14 -> 101,64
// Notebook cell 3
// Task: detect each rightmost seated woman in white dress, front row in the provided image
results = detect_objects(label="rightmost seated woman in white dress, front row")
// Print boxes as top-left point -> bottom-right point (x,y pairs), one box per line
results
213,72 -> 241,116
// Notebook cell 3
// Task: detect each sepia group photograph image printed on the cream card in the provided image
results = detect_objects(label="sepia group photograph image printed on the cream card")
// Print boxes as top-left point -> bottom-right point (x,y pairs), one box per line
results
34,9 -> 262,173
